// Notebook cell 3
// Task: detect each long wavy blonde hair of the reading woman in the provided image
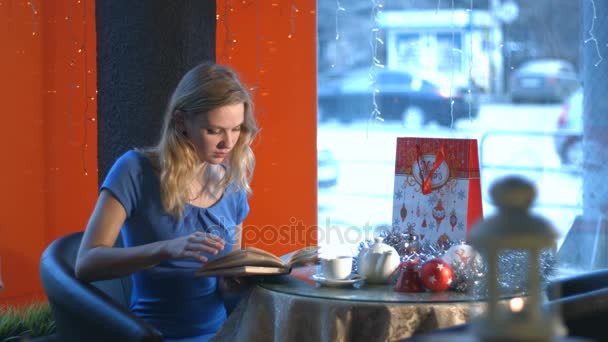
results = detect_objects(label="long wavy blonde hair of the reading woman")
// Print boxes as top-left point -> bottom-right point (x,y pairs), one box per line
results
139,62 -> 258,217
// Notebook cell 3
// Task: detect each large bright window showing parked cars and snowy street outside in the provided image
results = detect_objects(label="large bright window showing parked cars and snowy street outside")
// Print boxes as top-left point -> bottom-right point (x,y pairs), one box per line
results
317,0 -> 606,269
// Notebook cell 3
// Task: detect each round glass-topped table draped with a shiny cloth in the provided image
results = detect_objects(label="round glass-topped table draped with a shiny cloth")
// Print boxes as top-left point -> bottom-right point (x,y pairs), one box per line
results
214,267 -> 522,341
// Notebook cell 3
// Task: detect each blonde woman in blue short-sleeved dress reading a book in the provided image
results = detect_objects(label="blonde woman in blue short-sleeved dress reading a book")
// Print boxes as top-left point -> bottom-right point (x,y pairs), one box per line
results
76,63 -> 258,341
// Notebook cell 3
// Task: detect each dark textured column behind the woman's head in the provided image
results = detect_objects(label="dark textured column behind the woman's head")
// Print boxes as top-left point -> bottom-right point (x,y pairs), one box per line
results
96,0 -> 216,184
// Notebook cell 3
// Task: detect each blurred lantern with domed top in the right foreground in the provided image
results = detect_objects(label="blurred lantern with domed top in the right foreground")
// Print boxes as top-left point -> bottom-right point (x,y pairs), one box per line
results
470,176 -> 557,341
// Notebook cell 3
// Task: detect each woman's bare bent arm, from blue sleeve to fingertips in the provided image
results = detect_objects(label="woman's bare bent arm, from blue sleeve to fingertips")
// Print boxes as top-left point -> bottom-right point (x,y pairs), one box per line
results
76,190 -> 224,281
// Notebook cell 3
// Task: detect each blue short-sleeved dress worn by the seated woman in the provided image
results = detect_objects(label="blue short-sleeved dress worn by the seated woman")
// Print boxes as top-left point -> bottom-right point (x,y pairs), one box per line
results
101,150 -> 249,341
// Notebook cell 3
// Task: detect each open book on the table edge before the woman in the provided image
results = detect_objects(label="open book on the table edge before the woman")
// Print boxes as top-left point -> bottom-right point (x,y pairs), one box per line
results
196,246 -> 319,277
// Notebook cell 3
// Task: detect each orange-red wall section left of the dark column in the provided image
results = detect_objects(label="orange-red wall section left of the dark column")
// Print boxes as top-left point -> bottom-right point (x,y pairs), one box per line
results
0,0 -> 97,304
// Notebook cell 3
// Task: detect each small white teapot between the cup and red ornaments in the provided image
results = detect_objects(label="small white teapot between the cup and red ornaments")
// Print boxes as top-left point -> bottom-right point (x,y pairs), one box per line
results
357,237 -> 401,284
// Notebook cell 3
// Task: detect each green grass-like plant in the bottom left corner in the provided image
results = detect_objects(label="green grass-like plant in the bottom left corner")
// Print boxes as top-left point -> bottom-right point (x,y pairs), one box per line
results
0,302 -> 55,341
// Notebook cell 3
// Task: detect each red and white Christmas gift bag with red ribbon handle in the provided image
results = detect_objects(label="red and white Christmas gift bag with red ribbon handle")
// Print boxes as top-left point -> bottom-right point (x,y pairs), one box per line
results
393,137 -> 483,247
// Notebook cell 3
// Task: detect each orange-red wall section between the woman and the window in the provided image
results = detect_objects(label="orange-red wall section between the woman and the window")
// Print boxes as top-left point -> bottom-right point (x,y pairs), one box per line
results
216,0 -> 317,255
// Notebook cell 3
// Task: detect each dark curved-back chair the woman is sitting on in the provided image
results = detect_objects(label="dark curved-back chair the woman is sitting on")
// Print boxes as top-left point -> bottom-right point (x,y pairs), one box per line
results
40,232 -> 163,342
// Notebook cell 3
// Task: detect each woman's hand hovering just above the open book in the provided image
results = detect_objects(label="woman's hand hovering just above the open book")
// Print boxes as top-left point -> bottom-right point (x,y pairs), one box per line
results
165,232 -> 224,262
